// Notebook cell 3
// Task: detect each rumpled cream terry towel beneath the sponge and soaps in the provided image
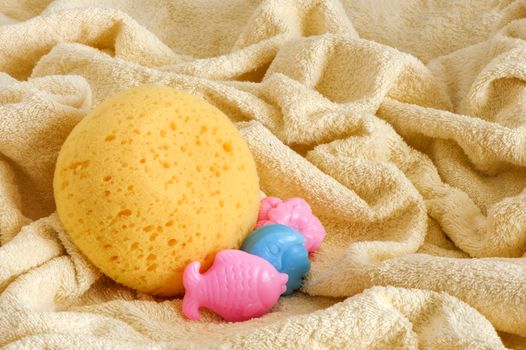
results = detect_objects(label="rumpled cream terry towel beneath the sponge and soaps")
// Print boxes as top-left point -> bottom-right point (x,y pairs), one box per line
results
0,0 -> 526,349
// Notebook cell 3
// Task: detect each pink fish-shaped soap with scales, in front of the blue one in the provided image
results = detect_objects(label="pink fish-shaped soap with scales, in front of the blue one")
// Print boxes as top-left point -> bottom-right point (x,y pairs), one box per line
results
183,250 -> 288,322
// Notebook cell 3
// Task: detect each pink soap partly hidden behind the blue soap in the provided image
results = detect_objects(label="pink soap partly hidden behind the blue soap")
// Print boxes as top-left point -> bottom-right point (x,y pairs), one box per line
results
256,197 -> 325,252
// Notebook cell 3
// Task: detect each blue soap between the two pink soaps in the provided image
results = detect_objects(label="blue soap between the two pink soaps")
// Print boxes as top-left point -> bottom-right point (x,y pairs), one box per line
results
241,225 -> 310,295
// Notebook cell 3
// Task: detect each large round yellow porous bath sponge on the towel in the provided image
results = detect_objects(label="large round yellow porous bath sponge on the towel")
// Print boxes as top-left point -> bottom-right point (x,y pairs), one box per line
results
54,85 -> 259,296
